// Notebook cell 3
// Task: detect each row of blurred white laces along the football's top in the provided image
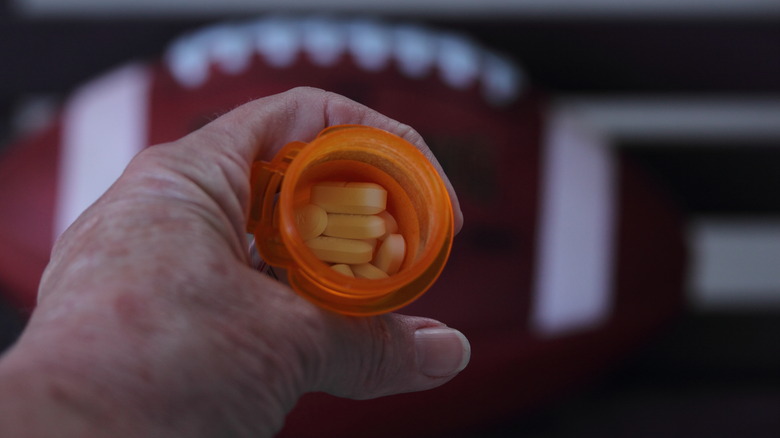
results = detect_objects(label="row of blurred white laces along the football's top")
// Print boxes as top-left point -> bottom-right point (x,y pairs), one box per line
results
165,16 -> 524,105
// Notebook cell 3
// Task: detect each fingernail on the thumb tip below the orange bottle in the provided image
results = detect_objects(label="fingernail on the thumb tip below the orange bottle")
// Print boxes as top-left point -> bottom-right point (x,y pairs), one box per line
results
414,327 -> 471,377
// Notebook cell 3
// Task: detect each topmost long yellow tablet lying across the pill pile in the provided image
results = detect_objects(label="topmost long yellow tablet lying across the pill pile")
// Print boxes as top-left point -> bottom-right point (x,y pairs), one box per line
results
311,182 -> 387,214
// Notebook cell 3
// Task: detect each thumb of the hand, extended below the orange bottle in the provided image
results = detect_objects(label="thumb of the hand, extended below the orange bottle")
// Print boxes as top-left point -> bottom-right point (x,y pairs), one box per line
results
320,314 -> 471,399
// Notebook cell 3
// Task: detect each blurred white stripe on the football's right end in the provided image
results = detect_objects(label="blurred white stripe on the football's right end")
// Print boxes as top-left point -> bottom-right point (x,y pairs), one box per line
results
531,111 -> 615,336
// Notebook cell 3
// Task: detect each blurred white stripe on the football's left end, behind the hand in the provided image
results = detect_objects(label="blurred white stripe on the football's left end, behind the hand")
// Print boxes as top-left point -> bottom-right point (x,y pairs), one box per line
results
54,65 -> 150,238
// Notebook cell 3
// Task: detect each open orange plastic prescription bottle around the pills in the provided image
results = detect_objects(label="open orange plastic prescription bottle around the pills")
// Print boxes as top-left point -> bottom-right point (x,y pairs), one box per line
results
247,125 -> 454,315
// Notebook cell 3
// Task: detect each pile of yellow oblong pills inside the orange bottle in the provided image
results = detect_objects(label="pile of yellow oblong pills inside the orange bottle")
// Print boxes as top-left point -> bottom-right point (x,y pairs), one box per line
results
295,181 -> 406,279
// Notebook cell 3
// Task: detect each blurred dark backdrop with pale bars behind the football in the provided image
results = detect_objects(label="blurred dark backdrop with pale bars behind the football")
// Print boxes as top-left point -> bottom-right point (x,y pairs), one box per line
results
0,0 -> 780,437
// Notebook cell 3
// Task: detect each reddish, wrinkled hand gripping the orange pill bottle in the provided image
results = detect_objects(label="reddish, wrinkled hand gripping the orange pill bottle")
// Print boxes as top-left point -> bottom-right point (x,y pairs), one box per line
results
0,88 -> 469,437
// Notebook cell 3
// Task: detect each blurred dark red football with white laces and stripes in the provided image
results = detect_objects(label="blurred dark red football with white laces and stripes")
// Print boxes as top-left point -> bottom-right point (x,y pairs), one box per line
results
0,16 -> 685,437
